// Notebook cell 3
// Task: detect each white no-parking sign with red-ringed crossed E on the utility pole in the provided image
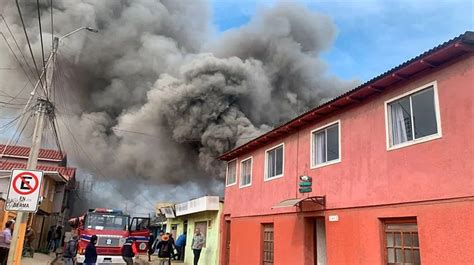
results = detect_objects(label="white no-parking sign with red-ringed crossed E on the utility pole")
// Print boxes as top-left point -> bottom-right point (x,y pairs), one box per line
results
5,169 -> 43,212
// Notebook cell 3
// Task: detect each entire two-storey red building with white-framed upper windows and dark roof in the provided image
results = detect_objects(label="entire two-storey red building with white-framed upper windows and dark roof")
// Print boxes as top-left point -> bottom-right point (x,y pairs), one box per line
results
220,32 -> 474,265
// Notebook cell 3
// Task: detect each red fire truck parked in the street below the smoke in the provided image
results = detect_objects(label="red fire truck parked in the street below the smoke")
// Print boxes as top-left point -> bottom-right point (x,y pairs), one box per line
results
69,208 -> 150,264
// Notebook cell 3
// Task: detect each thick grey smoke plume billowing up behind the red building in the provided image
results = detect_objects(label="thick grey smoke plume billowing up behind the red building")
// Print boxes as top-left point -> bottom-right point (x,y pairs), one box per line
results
0,0 -> 354,210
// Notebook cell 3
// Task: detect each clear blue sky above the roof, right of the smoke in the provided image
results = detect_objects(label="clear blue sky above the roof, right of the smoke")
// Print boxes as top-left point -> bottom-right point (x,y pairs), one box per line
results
212,0 -> 474,82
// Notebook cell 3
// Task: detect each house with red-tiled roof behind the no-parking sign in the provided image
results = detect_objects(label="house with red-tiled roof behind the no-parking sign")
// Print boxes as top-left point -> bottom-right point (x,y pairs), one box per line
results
0,145 -> 76,249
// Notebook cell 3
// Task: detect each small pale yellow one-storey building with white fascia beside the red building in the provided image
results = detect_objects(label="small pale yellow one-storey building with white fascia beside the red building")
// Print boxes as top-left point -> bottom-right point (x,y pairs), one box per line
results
158,196 -> 224,265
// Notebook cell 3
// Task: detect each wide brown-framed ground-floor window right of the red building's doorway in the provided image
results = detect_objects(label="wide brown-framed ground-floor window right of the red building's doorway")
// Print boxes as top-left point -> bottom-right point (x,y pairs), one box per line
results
384,220 -> 421,265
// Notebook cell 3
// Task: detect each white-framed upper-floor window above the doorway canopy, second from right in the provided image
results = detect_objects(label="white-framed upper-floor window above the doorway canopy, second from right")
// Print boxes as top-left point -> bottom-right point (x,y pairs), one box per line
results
311,122 -> 341,167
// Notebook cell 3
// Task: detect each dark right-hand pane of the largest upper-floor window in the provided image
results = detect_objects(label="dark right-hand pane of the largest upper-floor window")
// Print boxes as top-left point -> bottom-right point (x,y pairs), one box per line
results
411,88 -> 438,138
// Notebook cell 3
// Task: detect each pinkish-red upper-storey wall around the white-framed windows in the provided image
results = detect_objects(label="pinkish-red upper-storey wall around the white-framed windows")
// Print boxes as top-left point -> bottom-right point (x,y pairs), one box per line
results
225,53 -> 474,217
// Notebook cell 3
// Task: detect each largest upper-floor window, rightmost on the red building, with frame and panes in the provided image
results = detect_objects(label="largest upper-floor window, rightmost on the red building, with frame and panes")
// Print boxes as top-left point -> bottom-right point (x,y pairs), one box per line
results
387,85 -> 440,147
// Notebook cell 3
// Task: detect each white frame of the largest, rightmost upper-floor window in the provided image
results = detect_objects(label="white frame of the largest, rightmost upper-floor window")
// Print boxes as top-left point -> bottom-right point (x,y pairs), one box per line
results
385,81 -> 443,151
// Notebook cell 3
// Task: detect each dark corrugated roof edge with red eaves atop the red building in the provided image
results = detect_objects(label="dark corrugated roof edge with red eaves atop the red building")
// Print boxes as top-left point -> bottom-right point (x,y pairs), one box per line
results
218,31 -> 474,161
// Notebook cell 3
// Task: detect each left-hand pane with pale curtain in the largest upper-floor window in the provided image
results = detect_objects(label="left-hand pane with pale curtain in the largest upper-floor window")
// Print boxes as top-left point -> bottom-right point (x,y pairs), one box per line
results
389,97 -> 413,145
